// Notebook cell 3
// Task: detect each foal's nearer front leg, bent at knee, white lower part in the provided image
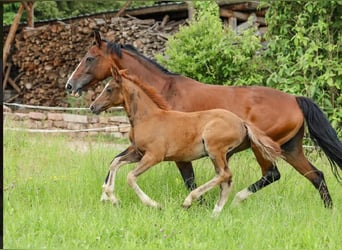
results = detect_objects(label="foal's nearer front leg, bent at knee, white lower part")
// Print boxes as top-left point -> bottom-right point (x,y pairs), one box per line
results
127,152 -> 161,208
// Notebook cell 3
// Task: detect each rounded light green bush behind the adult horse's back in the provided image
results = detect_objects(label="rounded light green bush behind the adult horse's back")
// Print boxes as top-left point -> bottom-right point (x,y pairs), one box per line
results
156,1 -> 262,85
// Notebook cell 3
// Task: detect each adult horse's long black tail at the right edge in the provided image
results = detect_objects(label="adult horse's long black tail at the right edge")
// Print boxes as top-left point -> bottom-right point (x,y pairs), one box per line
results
296,96 -> 342,181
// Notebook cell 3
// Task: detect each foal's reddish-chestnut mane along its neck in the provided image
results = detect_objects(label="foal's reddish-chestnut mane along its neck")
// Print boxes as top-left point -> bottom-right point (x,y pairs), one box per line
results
121,72 -> 171,110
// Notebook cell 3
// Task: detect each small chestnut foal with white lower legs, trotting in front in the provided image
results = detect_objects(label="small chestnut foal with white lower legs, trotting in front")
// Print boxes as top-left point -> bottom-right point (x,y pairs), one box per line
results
90,67 -> 281,215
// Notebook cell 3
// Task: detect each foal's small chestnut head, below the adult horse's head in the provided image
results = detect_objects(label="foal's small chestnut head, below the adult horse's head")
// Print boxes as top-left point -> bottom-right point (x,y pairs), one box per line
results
90,67 -> 126,114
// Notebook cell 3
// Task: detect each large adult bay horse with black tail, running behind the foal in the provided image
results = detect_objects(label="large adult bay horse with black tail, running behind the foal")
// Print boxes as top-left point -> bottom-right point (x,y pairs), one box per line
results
66,32 -> 342,207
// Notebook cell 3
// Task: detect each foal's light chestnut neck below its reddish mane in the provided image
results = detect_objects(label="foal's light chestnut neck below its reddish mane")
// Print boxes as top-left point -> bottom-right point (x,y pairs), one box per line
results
122,82 -> 161,127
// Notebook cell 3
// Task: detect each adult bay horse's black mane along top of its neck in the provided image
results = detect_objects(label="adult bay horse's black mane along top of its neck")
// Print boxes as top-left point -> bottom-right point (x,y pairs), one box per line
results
106,41 -> 178,75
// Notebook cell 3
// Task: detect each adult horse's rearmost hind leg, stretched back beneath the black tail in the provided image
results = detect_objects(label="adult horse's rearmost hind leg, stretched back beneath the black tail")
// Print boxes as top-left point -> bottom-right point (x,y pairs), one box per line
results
282,128 -> 332,208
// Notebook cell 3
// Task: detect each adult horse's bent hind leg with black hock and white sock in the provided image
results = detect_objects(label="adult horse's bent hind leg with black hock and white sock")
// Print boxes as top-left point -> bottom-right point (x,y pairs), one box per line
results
232,144 -> 280,205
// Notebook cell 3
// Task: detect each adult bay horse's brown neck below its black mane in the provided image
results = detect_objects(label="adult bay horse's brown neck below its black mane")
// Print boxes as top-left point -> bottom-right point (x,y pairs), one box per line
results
114,50 -> 169,93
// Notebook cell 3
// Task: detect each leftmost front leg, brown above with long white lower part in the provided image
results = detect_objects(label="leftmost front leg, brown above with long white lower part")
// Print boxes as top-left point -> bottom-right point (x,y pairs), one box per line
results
101,145 -> 141,204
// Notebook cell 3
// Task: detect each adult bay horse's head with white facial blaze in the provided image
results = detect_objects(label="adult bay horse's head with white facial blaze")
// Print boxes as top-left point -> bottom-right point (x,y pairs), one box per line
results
65,31 -> 111,96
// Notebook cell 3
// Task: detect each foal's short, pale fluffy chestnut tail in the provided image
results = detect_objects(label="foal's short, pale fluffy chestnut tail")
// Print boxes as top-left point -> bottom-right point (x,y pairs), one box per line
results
244,122 -> 281,162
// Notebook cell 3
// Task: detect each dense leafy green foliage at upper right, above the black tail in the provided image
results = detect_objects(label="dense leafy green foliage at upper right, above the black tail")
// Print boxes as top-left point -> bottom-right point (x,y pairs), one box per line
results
264,1 -> 342,135
